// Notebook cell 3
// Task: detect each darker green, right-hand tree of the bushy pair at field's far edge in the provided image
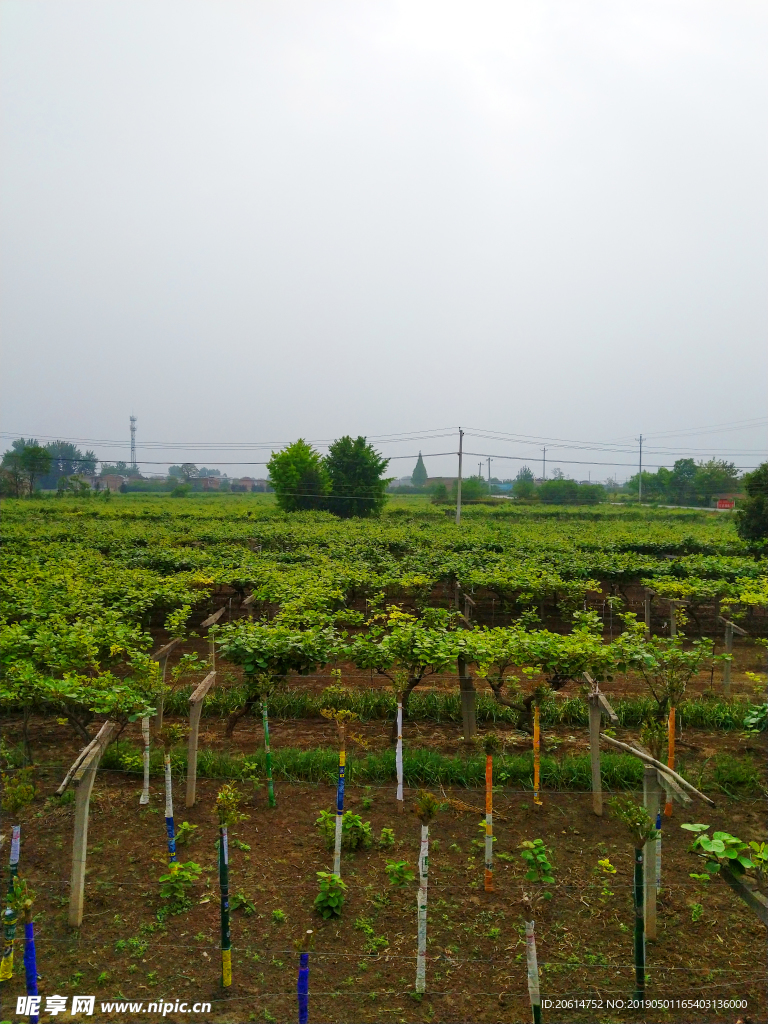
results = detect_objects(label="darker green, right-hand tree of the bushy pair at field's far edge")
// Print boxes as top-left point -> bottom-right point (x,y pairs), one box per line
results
325,436 -> 391,518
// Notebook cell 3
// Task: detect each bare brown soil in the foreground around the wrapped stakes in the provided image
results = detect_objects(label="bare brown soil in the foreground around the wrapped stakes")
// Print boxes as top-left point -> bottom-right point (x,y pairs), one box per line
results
3,761 -> 767,1024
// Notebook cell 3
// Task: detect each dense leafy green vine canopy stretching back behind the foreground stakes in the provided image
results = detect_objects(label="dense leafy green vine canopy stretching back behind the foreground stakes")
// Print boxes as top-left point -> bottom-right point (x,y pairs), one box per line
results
0,496 -> 768,736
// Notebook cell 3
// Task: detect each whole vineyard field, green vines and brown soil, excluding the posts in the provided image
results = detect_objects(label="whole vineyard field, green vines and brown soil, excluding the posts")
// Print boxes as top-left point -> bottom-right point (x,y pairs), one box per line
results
0,495 -> 768,1022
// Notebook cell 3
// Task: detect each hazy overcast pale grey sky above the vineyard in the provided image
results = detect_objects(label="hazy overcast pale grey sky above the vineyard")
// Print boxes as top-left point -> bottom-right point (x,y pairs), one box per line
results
0,0 -> 768,479
